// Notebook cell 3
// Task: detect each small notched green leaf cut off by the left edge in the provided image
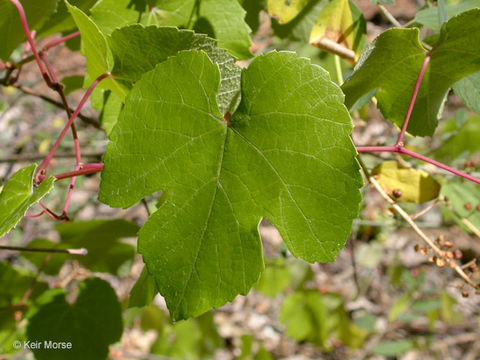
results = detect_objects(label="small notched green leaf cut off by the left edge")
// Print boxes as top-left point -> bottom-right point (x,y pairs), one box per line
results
0,164 -> 55,237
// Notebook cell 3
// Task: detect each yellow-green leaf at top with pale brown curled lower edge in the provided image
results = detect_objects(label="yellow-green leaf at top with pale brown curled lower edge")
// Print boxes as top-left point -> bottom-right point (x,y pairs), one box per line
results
310,0 -> 366,60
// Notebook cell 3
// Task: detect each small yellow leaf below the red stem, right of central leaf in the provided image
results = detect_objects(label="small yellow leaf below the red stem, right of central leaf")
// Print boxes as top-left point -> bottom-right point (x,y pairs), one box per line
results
372,161 -> 440,204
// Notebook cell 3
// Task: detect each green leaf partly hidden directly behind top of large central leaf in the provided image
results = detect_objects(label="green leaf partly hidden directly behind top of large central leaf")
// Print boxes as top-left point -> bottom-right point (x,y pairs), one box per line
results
109,25 -> 241,114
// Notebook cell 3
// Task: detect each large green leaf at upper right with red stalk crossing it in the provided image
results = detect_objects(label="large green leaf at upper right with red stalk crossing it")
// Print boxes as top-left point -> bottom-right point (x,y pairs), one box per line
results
342,9 -> 480,136
